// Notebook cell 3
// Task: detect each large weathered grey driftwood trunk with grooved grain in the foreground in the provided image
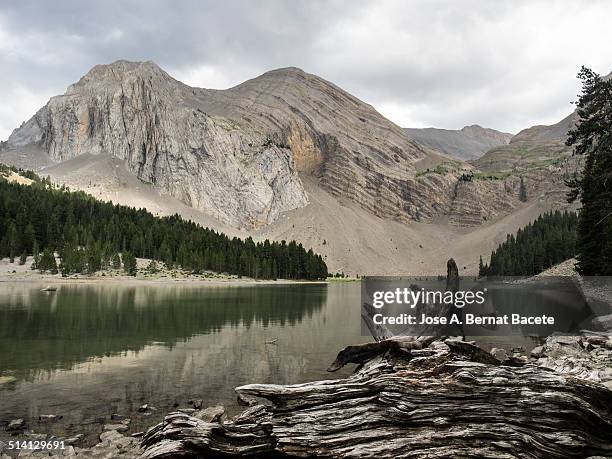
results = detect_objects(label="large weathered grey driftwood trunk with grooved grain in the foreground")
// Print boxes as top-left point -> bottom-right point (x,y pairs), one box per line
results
142,339 -> 612,459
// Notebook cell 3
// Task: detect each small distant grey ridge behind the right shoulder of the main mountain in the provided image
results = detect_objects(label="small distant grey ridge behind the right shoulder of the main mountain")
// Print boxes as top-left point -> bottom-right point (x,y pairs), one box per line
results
404,124 -> 512,160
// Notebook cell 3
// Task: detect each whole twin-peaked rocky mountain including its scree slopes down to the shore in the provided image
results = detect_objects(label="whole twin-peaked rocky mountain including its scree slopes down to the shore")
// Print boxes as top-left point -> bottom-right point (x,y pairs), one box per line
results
0,61 -> 562,275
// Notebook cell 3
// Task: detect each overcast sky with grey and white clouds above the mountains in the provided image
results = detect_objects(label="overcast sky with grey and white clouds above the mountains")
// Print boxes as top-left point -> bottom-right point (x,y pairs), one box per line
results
0,0 -> 612,139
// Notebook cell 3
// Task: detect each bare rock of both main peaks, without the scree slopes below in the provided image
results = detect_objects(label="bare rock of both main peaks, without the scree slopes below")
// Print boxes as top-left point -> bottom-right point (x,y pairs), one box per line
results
3,61 -> 532,229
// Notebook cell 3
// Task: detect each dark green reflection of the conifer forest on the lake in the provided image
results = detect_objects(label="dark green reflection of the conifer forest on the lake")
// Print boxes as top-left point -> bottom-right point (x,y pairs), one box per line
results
0,285 -> 327,381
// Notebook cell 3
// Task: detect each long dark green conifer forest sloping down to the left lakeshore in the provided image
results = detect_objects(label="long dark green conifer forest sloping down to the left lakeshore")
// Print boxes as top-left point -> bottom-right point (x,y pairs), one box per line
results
0,174 -> 327,280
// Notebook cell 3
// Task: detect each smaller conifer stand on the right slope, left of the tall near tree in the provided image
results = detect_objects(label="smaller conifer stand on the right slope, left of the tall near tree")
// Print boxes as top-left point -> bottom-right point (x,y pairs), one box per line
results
479,211 -> 578,276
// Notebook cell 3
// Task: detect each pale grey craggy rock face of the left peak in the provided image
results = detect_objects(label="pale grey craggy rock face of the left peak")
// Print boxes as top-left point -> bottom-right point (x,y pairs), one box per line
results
8,62 -> 308,227
